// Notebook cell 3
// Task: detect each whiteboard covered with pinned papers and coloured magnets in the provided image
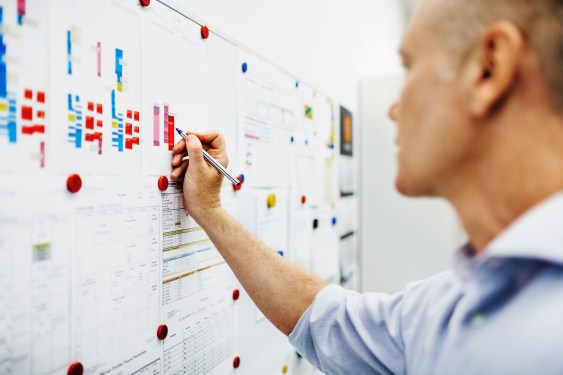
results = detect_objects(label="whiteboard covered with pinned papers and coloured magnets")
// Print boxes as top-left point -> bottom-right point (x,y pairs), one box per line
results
0,0 -> 357,374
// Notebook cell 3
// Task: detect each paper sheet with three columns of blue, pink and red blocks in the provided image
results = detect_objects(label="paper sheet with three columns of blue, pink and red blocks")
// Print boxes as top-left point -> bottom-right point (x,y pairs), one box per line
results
47,0 -> 145,176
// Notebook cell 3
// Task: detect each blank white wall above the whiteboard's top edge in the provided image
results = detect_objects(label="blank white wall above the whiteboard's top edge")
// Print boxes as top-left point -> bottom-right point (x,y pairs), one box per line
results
171,0 -> 404,112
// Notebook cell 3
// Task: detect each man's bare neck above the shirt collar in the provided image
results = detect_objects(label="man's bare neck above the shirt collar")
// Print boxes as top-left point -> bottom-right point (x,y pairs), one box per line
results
440,116 -> 563,252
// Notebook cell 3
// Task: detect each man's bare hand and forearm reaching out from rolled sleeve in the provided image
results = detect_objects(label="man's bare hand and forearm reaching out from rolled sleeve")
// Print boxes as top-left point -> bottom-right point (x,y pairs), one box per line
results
171,132 -> 326,335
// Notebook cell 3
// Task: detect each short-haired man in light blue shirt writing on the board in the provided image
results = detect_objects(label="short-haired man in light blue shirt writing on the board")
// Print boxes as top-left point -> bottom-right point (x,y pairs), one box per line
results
172,0 -> 563,374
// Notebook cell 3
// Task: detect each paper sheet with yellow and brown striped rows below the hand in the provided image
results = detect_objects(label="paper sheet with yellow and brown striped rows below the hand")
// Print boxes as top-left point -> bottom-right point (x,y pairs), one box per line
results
160,181 -> 236,374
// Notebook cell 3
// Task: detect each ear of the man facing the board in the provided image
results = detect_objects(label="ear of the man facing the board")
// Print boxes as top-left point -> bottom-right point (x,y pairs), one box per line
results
466,21 -> 525,118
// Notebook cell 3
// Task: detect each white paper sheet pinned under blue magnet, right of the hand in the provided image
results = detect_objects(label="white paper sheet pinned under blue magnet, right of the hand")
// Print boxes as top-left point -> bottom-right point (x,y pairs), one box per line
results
236,49 -> 297,188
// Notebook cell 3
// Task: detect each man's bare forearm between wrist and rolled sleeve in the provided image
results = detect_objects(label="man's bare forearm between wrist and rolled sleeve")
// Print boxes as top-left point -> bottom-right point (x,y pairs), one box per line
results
196,209 -> 326,335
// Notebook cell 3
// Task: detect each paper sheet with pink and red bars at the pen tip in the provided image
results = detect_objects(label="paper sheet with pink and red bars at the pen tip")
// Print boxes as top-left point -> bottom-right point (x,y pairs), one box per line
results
142,3 -> 208,175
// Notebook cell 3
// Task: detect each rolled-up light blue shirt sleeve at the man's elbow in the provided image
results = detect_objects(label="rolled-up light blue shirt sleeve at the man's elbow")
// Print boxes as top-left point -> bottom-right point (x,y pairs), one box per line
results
289,285 -> 405,374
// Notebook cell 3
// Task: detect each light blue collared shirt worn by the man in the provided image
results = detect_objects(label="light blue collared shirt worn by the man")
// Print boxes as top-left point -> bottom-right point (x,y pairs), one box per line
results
289,193 -> 563,375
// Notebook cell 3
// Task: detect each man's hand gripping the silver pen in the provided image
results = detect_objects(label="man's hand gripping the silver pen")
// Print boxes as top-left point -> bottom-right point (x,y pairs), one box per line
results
170,131 -> 229,224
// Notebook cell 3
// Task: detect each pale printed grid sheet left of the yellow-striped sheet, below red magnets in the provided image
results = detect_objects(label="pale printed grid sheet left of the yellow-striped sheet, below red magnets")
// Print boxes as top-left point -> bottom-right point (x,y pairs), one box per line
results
76,206 -> 160,358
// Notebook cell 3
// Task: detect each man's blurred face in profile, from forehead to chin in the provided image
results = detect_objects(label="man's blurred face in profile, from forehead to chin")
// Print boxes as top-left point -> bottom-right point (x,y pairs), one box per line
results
390,4 -> 474,196
